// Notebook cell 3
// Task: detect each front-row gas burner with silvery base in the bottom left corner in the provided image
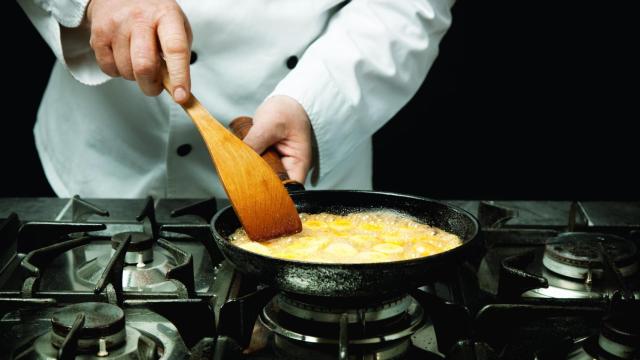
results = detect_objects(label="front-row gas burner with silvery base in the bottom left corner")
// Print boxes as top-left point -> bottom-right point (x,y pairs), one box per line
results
9,302 -> 188,360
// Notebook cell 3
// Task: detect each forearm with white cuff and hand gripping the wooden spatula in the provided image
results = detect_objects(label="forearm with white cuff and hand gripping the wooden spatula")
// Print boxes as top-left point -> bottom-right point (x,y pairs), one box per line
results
18,0 -> 191,103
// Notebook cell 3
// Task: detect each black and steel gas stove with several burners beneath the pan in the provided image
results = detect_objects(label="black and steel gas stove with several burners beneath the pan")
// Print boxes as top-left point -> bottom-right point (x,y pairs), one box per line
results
0,196 -> 640,359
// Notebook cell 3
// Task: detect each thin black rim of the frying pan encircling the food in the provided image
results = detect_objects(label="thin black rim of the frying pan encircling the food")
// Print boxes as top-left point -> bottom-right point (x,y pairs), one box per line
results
210,189 -> 480,270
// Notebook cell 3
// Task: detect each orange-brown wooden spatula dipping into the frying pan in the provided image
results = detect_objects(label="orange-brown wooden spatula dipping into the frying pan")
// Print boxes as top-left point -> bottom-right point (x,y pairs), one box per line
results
162,69 -> 302,241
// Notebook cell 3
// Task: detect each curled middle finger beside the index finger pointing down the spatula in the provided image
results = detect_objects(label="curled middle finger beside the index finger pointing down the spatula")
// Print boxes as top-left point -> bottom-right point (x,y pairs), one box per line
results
131,23 -> 162,96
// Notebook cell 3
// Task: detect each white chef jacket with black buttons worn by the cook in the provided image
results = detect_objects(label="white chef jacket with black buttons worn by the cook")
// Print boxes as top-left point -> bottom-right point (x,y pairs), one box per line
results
18,0 -> 453,198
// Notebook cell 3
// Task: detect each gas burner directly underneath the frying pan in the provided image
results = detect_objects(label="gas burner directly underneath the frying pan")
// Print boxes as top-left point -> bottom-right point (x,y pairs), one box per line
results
260,294 -> 424,359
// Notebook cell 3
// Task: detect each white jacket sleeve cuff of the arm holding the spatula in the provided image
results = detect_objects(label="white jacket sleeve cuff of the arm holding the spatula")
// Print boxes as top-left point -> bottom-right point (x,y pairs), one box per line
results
18,0 -> 110,85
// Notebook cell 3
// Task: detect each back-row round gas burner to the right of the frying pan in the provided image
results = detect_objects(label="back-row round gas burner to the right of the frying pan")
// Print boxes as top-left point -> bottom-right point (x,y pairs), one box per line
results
542,232 -> 638,283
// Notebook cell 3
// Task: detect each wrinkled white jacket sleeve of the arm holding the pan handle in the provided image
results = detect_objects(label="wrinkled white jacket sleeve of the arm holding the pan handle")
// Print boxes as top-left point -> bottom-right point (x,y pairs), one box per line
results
269,0 -> 453,183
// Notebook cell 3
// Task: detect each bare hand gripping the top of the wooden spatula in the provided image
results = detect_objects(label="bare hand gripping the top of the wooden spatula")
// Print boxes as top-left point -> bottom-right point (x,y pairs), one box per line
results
86,0 -> 192,103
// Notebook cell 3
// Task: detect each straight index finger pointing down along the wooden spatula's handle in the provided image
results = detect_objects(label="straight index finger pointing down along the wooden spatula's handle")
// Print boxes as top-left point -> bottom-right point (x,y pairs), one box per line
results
158,11 -> 191,104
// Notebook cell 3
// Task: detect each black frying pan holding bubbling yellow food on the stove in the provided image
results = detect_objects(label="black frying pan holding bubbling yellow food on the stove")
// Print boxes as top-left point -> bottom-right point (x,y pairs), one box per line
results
211,118 -> 480,298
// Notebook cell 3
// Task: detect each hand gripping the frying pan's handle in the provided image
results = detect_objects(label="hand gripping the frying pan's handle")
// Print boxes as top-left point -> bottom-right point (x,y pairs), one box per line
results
244,95 -> 311,183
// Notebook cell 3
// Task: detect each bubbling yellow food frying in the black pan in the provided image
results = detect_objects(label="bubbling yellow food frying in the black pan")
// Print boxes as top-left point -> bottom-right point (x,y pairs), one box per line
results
230,211 -> 462,263
